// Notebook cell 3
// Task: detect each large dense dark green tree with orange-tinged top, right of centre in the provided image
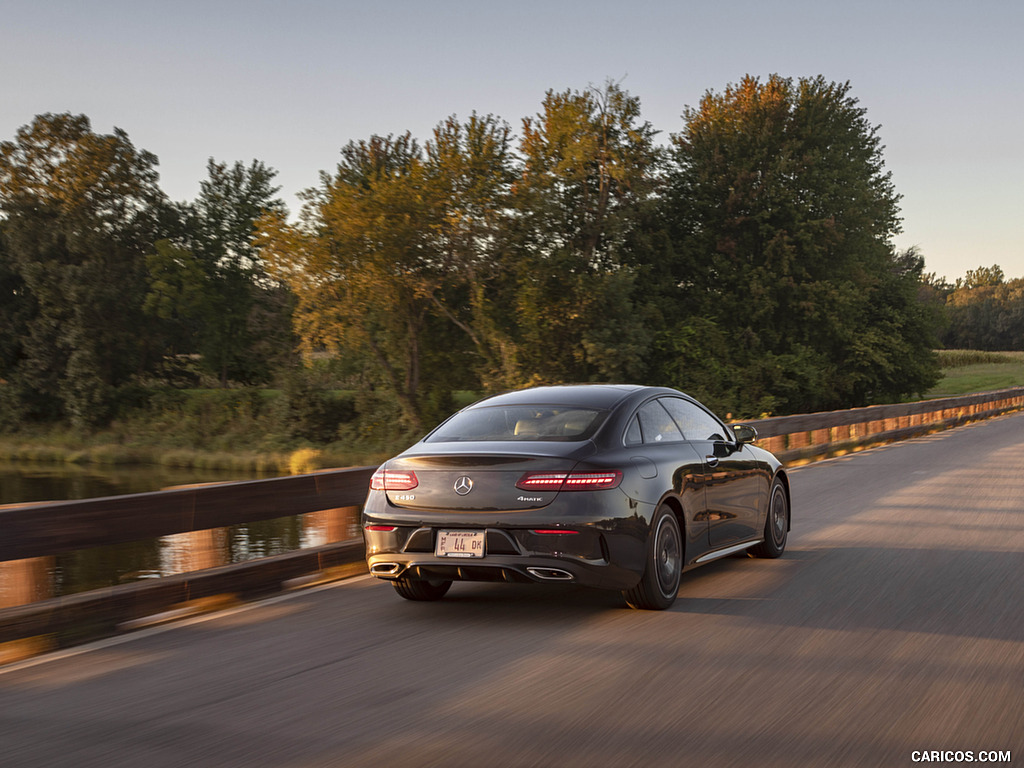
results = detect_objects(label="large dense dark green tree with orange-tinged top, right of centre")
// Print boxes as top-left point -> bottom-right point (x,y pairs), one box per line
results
657,75 -> 938,414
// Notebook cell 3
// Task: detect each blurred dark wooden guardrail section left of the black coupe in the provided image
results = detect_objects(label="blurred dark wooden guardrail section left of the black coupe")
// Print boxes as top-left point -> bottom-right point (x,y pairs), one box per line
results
0,467 -> 376,664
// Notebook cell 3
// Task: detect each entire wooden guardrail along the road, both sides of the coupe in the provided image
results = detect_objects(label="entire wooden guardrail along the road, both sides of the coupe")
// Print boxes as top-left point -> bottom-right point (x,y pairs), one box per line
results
0,387 -> 1024,663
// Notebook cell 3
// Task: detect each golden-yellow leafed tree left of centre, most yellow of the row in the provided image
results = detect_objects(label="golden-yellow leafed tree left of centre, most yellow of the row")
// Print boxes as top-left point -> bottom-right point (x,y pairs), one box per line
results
261,133 -> 445,430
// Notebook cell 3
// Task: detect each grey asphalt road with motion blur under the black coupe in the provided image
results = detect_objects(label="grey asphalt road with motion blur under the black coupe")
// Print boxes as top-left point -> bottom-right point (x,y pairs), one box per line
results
0,414 -> 1024,768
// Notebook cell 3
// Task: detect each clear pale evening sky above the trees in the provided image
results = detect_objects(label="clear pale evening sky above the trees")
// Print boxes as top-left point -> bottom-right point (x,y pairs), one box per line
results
0,0 -> 1024,281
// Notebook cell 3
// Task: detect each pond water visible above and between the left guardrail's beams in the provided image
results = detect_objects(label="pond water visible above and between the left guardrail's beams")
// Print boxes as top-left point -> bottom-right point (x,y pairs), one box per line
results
0,462 -> 344,605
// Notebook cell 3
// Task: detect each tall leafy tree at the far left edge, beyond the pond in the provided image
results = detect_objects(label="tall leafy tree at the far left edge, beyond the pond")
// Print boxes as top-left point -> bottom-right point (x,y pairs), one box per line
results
0,114 -> 164,425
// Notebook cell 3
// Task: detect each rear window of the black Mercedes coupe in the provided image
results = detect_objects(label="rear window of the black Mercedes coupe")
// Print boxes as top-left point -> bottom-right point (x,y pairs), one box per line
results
426,406 -> 607,442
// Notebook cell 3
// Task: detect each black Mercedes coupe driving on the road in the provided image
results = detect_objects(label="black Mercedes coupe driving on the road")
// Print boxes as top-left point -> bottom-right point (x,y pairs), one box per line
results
362,384 -> 791,609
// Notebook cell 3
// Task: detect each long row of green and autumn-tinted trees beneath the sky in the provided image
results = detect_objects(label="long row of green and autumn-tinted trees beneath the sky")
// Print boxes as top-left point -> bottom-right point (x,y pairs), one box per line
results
0,76 -> 1024,438
